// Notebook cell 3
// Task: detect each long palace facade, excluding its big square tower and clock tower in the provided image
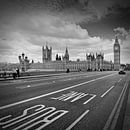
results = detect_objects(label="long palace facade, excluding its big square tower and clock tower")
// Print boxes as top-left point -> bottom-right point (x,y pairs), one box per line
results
30,47 -> 113,71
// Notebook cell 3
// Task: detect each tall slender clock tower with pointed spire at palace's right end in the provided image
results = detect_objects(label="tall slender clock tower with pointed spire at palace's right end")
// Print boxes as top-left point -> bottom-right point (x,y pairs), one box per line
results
113,37 -> 120,70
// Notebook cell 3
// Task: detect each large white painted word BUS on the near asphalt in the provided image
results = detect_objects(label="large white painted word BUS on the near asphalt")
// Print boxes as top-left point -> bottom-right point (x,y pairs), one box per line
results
0,104 -> 69,130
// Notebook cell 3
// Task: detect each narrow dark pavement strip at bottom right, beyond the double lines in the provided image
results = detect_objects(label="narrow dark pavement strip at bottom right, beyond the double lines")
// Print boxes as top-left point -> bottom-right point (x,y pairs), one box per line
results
123,87 -> 130,130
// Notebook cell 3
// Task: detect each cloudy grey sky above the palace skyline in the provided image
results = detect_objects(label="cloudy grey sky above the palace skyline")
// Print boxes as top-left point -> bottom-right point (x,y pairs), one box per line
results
0,0 -> 130,63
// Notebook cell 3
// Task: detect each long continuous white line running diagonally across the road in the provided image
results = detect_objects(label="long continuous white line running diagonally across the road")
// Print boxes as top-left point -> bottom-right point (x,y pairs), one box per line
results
0,73 -> 115,110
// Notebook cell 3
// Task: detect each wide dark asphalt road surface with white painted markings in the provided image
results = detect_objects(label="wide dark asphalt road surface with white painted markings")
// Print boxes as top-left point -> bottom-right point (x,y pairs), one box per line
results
0,71 -> 130,130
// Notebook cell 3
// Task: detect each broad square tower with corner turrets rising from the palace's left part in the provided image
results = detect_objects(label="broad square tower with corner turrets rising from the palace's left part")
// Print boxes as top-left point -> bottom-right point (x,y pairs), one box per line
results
42,45 -> 52,63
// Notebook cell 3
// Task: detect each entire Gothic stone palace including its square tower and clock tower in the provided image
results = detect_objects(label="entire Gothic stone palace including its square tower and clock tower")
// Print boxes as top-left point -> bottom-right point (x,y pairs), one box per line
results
30,37 -> 120,71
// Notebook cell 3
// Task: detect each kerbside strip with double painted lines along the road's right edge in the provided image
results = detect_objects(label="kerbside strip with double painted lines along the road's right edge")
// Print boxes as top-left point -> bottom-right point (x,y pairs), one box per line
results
103,81 -> 129,130
